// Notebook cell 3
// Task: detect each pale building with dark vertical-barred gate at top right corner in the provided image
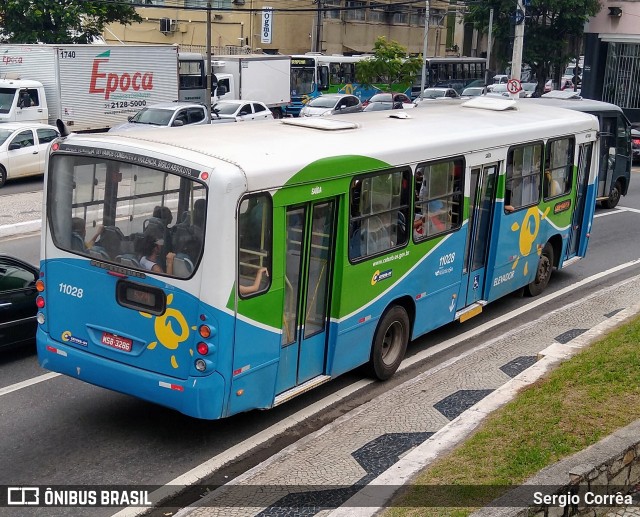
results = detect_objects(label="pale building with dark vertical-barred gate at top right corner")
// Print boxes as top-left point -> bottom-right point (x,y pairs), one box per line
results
582,0 -> 640,122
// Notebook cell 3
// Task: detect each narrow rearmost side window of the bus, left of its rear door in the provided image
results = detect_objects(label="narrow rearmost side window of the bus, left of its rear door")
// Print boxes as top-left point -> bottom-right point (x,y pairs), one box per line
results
237,194 -> 273,298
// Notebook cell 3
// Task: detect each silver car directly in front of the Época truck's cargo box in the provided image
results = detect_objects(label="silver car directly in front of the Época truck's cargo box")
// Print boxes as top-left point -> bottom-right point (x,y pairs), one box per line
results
109,102 -> 210,133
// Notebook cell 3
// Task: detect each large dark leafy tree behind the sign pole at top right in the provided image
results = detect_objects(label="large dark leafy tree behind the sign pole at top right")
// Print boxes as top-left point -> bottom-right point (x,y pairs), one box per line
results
465,0 -> 600,92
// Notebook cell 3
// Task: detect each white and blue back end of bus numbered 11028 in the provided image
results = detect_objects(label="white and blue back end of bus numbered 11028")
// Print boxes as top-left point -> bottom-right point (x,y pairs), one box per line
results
37,135 -> 224,418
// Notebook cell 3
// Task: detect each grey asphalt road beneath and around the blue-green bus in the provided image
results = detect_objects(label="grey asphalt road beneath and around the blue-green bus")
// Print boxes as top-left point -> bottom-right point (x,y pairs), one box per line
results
0,169 -> 640,515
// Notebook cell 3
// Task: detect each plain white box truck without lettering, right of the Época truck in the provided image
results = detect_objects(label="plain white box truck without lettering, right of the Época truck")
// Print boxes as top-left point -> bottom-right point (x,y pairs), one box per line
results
211,54 -> 291,118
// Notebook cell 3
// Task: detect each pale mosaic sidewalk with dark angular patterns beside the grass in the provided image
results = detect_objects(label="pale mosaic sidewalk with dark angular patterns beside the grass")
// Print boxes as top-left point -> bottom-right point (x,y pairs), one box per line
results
177,277 -> 640,517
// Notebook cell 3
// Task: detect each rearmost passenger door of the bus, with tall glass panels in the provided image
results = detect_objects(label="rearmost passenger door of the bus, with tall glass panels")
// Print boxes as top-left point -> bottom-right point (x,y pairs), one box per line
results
276,200 -> 336,393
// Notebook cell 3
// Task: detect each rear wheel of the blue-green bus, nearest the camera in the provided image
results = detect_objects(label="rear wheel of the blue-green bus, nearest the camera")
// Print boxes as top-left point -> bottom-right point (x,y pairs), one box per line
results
369,305 -> 409,381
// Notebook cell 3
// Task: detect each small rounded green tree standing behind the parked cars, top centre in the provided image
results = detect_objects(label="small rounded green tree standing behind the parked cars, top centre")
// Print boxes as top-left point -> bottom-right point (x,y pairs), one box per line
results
356,36 -> 422,92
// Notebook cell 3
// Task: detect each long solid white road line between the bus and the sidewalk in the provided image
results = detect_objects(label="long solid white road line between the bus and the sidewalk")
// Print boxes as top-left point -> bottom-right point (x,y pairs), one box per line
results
112,258 -> 640,517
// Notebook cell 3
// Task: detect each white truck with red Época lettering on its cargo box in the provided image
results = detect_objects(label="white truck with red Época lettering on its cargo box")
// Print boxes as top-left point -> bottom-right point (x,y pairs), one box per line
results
0,45 -> 194,132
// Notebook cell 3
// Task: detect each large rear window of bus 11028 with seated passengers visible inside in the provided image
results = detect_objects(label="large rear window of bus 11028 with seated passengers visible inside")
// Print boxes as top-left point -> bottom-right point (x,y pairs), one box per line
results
47,155 -> 206,278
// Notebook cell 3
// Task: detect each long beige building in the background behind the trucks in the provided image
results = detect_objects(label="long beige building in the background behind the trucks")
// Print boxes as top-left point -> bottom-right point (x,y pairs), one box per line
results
103,0 -> 486,57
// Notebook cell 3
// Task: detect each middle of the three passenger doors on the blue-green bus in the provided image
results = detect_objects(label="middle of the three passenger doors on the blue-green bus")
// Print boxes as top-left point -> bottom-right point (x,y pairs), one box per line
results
464,163 -> 498,307
